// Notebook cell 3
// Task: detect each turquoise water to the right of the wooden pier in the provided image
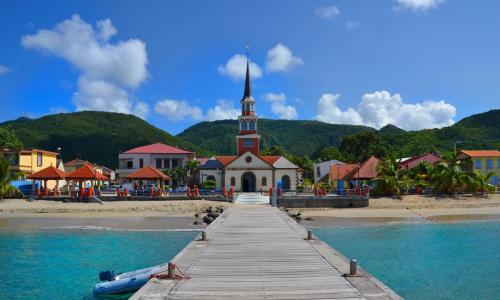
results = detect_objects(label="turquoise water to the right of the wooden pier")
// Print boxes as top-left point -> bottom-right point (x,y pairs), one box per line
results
313,222 -> 500,299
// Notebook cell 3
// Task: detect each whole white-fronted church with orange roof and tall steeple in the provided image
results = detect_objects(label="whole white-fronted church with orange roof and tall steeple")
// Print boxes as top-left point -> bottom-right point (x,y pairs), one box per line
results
200,61 -> 299,192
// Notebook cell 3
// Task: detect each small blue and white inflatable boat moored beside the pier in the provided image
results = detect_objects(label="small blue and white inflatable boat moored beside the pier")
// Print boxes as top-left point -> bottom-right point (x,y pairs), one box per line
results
93,264 -> 168,295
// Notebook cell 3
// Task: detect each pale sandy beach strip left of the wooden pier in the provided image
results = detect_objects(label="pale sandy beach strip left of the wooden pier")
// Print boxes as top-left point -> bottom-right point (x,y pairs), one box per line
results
0,199 -> 231,230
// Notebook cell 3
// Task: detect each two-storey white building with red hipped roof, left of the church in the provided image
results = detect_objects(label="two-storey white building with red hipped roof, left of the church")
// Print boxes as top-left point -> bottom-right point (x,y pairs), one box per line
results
116,143 -> 195,186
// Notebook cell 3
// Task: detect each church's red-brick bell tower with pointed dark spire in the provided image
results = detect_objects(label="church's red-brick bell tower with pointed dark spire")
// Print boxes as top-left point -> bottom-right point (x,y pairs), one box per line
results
236,61 -> 260,156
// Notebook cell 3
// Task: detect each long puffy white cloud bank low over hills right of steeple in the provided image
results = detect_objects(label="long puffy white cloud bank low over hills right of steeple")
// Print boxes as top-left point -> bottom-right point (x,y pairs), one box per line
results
316,91 -> 456,130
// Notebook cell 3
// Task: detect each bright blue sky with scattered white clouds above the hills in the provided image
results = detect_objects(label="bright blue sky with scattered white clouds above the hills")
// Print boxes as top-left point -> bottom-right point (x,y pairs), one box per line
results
0,0 -> 500,134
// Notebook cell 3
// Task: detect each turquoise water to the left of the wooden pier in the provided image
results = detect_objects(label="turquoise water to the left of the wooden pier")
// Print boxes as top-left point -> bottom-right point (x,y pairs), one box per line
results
0,230 -> 198,299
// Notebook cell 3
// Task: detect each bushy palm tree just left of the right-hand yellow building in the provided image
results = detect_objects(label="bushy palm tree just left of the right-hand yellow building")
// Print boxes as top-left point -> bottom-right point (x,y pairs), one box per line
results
431,152 -> 473,195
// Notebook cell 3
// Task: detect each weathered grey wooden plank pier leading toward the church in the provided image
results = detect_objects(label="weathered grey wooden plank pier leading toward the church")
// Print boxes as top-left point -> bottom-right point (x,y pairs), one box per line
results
131,205 -> 399,300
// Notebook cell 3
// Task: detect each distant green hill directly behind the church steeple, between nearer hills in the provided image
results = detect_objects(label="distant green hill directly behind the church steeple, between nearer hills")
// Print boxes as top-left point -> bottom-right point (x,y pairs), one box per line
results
177,119 -> 375,156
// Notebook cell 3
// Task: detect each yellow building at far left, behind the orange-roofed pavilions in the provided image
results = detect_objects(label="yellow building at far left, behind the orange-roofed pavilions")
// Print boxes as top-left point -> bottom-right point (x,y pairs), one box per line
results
0,149 -> 59,188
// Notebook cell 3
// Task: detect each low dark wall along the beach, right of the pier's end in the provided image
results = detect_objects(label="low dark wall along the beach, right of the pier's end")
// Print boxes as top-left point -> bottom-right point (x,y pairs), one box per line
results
278,195 -> 369,208
